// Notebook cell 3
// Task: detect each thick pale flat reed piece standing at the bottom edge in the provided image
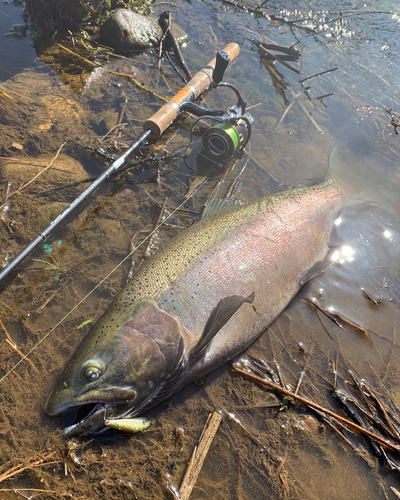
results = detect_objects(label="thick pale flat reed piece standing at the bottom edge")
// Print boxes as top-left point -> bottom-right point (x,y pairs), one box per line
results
179,411 -> 222,500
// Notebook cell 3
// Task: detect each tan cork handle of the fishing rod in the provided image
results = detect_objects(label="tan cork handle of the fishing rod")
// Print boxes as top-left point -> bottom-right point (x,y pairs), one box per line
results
143,43 -> 240,140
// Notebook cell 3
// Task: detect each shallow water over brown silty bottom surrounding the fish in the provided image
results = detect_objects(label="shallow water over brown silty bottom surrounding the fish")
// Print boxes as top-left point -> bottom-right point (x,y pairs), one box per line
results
0,1 -> 400,499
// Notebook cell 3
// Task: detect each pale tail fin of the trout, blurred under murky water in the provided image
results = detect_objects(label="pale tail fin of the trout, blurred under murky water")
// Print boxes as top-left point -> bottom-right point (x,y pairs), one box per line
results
325,148 -> 377,205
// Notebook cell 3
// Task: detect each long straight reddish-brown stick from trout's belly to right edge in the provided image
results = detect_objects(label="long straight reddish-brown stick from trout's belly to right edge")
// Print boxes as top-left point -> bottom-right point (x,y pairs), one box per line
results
232,364 -> 400,452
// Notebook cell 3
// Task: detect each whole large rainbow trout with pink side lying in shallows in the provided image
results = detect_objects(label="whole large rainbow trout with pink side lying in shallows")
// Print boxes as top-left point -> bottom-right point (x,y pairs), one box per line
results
45,150 -> 355,437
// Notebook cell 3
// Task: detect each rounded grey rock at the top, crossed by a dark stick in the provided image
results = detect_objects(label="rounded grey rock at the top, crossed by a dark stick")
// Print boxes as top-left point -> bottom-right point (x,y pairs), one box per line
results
100,9 -> 189,52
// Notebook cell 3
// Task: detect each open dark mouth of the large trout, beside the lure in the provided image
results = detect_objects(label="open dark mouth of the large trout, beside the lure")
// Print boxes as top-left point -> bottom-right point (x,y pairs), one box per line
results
63,403 -> 110,438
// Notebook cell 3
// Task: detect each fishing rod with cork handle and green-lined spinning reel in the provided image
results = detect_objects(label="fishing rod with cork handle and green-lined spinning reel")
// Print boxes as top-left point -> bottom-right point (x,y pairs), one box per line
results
0,43 -> 241,282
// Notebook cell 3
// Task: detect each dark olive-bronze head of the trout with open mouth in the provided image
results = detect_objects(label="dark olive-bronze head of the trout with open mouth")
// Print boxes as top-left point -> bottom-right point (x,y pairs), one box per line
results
45,300 -> 188,437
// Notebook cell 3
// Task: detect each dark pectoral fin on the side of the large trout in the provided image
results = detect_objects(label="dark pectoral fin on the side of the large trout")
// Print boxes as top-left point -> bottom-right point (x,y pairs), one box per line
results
190,292 -> 254,357
